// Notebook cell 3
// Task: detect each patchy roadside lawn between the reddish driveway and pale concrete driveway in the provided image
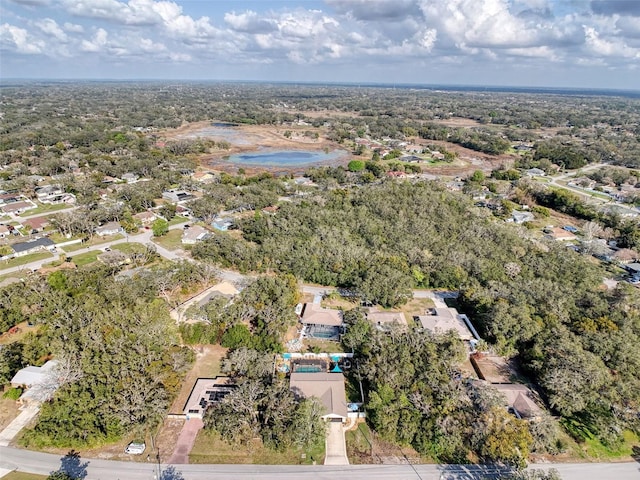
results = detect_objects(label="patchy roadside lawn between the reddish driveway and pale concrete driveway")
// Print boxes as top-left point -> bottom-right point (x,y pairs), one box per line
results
189,430 -> 324,465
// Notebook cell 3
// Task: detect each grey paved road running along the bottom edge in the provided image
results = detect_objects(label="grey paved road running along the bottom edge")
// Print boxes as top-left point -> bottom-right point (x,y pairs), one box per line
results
0,447 -> 640,480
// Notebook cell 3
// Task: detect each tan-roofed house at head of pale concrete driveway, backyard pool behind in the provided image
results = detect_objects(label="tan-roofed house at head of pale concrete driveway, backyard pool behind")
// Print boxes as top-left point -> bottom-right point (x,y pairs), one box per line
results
289,372 -> 348,423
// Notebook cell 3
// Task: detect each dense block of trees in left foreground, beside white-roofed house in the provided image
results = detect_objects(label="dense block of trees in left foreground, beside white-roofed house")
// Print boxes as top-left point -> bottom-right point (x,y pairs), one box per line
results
0,267 -> 193,447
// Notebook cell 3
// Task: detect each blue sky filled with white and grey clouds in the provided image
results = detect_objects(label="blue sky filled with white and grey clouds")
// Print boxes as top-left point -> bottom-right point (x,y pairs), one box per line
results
0,0 -> 640,90
